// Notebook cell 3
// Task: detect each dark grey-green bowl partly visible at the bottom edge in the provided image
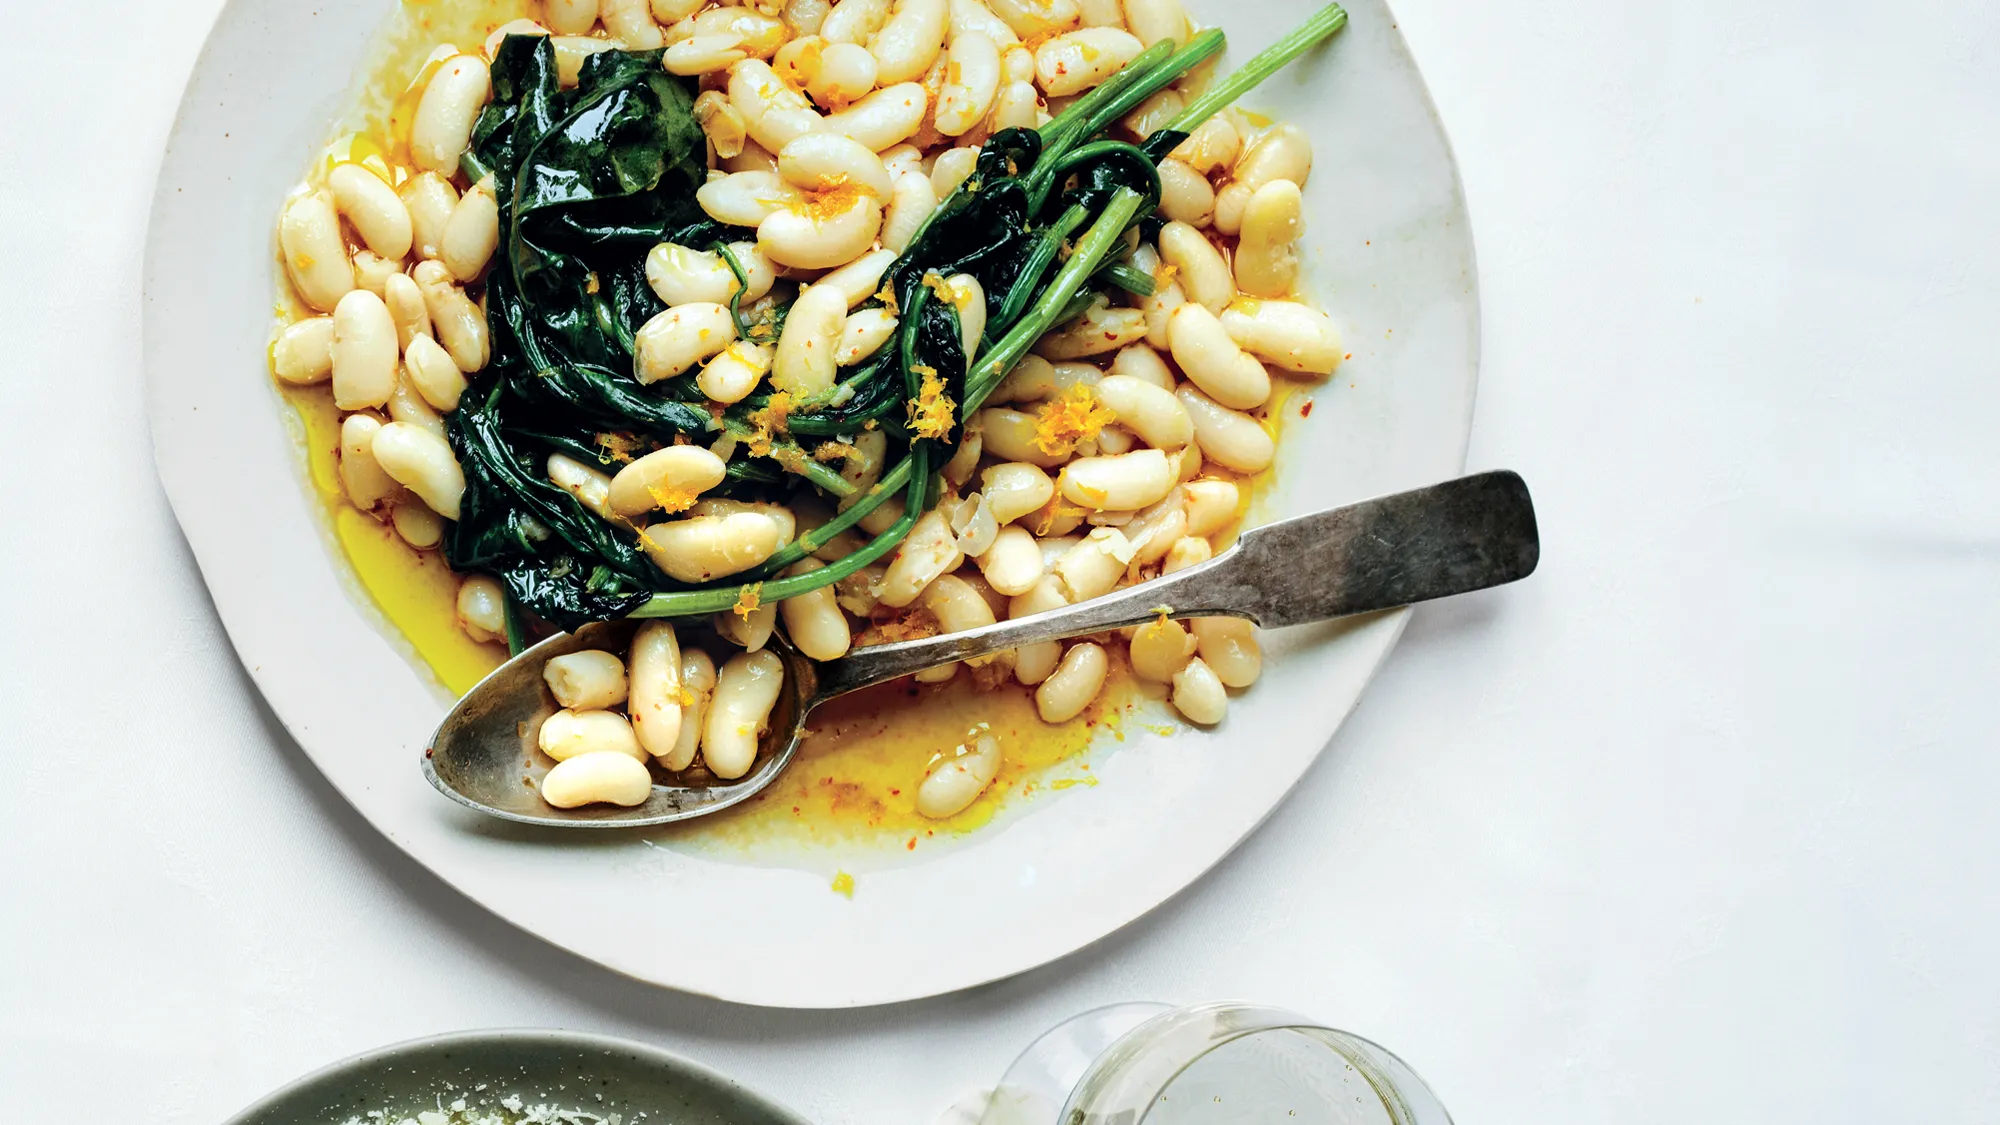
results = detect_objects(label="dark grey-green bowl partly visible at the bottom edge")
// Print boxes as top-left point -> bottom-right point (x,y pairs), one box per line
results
226,1031 -> 812,1125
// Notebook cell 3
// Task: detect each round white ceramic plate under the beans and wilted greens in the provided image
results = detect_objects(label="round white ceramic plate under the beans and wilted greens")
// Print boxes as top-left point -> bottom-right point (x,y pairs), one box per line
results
146,0 -> 1478,1007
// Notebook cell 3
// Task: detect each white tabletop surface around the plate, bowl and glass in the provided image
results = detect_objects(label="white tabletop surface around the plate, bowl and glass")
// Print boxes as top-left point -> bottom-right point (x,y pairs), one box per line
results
0,0 -> 2000,1125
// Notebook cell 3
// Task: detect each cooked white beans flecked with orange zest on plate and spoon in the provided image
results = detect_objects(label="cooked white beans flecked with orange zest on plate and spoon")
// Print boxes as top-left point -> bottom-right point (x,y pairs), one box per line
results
272,0 -> 1344,815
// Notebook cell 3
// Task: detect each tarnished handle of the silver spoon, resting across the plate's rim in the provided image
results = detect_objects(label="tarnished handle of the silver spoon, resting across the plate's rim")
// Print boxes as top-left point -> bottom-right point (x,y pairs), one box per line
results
814,472 -> 1542,701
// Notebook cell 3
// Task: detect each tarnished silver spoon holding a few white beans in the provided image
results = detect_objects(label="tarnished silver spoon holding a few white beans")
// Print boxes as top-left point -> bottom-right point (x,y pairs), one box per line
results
424,472 -> 1542,829
